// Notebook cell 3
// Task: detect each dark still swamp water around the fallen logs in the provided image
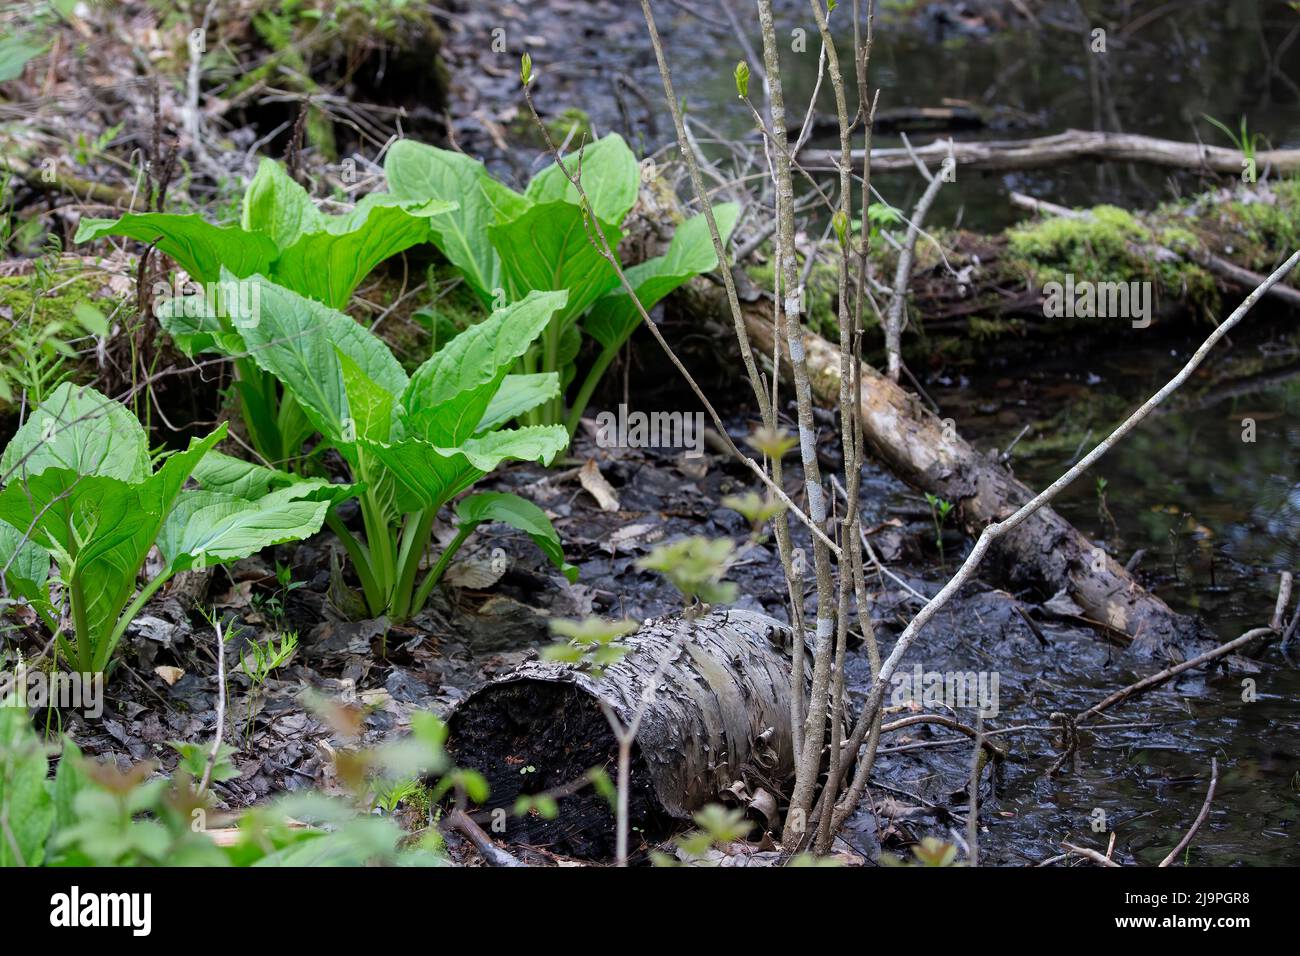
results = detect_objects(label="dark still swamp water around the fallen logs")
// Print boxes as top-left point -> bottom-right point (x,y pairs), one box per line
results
449,0 -> 1300,865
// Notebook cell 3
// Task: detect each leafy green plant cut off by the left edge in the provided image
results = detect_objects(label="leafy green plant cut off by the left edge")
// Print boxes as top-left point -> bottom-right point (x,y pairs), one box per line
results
0,382 -> 340,674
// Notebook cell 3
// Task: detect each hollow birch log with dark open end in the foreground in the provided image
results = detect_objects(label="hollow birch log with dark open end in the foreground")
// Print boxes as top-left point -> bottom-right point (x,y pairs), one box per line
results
447,610 -> 794,860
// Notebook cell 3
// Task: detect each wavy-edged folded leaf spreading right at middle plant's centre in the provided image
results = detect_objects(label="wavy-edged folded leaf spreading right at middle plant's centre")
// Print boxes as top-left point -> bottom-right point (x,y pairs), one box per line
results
363,425 -> 568,511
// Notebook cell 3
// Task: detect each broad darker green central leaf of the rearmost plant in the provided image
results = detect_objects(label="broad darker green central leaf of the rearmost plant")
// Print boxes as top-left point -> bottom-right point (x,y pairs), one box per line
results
488,200 -> 623,324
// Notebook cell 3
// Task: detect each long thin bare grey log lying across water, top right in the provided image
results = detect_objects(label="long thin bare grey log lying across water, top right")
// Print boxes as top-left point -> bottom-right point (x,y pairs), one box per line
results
798,130 -> 1300,177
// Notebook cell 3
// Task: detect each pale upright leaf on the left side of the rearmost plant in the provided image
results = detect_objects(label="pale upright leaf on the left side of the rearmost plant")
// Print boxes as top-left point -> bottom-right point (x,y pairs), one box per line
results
384,139 -> 528,302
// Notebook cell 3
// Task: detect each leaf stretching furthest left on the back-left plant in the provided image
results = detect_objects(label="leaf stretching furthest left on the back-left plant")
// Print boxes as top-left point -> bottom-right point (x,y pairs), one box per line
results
74,212 -> 278,282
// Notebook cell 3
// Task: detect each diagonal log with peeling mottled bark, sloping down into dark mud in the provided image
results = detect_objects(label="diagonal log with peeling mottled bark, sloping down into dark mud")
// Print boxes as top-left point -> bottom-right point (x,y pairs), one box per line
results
686,280 -> 1201,646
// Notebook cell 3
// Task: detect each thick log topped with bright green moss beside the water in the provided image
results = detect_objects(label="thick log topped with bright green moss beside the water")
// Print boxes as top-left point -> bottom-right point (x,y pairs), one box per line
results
748,179 -> 1300,368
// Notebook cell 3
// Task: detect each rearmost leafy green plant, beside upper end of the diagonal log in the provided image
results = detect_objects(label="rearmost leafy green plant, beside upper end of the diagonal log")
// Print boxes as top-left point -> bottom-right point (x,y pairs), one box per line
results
385,133 -> 740,436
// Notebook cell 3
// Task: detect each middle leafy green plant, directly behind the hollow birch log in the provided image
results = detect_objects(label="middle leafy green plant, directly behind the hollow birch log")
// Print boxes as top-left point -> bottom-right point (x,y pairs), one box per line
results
170,273 -> 577,620
